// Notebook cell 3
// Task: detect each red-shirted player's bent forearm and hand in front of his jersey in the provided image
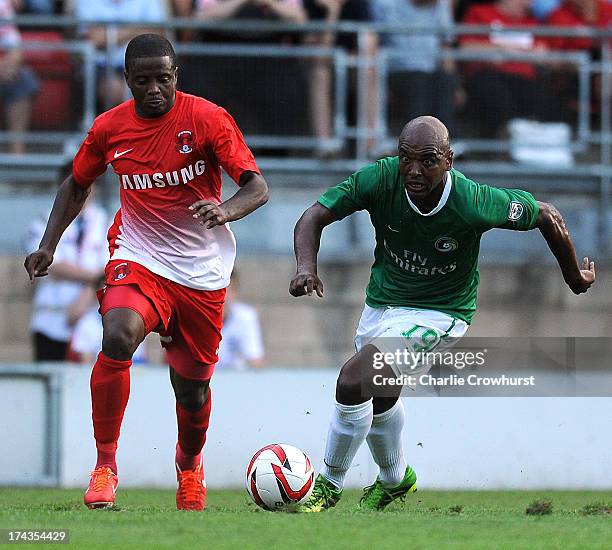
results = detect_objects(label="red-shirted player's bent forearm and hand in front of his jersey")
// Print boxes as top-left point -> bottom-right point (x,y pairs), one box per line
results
189,171 -> 270,229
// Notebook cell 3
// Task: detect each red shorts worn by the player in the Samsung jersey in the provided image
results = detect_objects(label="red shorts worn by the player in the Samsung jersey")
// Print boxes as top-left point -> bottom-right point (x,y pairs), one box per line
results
98,260 -> 225,380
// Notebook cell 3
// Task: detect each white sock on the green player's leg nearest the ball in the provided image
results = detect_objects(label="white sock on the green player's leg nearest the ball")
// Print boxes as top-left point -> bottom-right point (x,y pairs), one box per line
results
321,399 -> 374,489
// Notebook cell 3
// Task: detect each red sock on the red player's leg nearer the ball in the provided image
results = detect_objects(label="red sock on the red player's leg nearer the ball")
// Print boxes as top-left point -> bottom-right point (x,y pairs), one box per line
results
176,388 -> 212,470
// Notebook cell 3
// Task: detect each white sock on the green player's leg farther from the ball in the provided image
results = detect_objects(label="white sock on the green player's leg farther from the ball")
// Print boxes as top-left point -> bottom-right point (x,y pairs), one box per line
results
367,399 -> 407,485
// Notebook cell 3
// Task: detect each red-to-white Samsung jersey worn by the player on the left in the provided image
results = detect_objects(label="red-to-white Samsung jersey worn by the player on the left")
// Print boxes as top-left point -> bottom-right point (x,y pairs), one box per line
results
72,91 -> 259,290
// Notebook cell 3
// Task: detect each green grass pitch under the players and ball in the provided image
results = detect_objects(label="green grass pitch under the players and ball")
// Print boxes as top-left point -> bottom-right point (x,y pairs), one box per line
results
0,488 -> 612,550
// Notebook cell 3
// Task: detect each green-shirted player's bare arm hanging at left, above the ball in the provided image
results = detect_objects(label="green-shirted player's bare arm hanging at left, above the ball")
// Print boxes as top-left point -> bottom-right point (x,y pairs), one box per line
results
289,202 -> 336,297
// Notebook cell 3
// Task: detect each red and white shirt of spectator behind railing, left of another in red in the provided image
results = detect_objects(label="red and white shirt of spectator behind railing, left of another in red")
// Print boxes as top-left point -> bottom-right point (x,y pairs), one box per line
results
461,4 -> 544,78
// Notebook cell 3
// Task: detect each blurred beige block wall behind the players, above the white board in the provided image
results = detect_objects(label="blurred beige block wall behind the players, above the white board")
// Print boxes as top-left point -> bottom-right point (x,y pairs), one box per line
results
0,258 -> 612,368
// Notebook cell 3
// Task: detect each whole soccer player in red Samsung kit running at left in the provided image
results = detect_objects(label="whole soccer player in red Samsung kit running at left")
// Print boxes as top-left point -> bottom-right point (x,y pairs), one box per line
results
25,34 -> 268,510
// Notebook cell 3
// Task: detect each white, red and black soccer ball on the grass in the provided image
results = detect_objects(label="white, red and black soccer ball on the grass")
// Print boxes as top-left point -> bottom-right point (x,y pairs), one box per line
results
246,444 -> 314,512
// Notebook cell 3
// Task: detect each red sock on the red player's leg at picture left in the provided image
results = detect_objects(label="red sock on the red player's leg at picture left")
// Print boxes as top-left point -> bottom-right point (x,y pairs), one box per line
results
90,352 -> 132,473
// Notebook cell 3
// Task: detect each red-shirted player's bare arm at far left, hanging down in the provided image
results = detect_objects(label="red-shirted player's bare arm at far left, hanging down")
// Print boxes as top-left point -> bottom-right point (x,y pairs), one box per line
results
24,175 -> 91,283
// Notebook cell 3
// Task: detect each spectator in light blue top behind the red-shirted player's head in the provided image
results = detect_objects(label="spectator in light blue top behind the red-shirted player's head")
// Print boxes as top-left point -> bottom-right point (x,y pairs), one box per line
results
74,0 -> 166,110
